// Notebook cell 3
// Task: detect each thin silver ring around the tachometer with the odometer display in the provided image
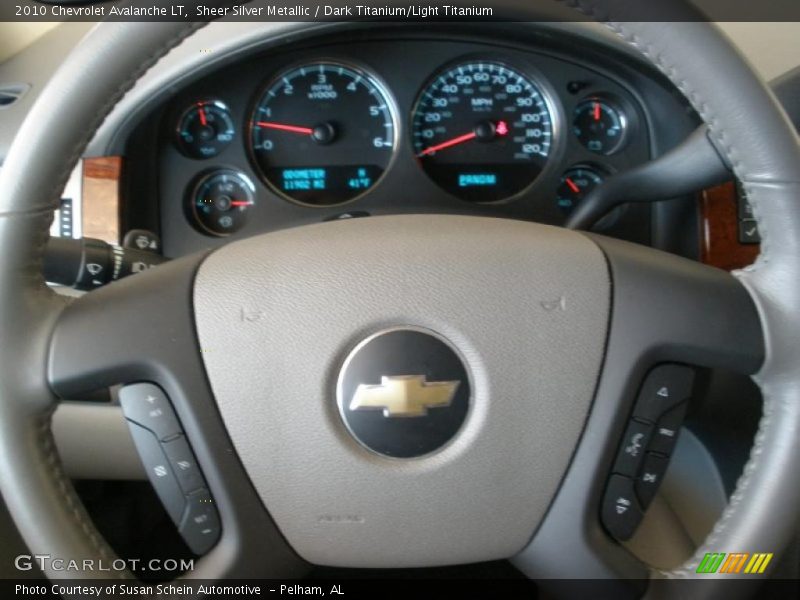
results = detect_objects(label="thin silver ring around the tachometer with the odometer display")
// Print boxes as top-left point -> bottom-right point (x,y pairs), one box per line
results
244,57 -> 402,209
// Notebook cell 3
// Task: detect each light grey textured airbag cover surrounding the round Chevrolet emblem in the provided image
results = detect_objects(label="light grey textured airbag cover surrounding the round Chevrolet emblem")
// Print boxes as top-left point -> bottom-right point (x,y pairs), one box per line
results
194,216 -> 611,567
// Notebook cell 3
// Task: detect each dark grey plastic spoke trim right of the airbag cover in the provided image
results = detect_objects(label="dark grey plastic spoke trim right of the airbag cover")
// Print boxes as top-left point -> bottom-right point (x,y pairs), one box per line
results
514,234 -> 765,598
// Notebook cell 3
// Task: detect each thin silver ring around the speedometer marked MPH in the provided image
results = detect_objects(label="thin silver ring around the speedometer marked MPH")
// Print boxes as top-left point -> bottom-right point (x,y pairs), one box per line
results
408,53 -> 566,206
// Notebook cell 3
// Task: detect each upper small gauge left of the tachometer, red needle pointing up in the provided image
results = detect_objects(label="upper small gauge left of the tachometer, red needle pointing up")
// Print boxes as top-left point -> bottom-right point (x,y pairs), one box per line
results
177,100 -> 236,158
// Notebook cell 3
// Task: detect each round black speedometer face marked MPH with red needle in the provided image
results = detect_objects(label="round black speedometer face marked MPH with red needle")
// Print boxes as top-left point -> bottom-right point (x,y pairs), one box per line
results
412,62 -> 554,202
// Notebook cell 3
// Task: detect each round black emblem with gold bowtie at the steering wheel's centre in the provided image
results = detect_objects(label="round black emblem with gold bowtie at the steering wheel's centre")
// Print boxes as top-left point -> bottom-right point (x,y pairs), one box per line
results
337,328 -> 471,458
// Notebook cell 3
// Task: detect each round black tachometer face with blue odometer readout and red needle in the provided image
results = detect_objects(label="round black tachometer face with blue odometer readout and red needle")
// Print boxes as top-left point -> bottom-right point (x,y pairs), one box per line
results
250,63 -> 396,206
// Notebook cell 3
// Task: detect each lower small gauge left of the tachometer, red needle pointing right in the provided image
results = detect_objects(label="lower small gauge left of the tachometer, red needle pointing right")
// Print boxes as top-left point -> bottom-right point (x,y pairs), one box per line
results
189,169 -> 255,236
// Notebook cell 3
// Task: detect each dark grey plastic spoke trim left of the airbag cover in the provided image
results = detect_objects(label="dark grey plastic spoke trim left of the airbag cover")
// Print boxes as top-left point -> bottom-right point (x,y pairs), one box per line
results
48,255 -> 308,579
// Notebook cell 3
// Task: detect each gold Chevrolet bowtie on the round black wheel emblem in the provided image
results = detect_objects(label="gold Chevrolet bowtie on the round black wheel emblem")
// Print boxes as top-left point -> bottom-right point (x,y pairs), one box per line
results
350,375 -> 461,417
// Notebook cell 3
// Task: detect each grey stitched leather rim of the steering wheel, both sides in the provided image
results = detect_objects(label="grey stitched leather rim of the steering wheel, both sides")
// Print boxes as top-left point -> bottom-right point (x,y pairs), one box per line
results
0,0 -> 800,592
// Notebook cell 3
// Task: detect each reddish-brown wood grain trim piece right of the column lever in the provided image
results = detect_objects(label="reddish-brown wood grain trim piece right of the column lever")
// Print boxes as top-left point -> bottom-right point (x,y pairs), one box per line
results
700,182 -> 760,271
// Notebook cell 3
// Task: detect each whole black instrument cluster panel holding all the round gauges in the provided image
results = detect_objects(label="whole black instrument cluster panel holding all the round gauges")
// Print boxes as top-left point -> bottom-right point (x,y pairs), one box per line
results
153,35 -> 650,254
